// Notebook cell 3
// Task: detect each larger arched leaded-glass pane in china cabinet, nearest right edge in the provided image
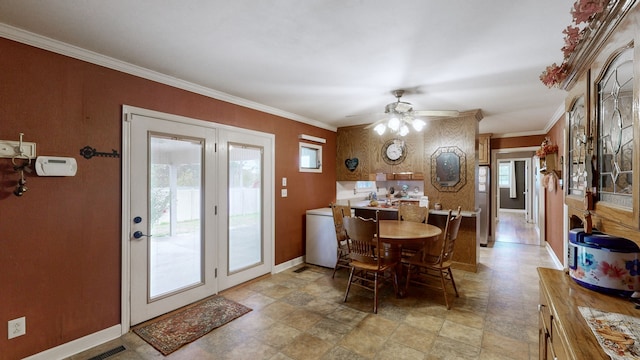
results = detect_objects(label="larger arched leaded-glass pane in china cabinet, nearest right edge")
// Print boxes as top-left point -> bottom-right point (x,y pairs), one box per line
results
598,49 -> 633,208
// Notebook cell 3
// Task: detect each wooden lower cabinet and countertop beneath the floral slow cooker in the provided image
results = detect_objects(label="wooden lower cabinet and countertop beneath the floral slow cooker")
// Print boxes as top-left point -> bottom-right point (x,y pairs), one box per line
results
538,268 -> 638,360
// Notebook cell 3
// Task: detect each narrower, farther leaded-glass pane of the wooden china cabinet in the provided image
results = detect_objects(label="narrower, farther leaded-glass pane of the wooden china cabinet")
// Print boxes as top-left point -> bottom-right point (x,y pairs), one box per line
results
567,96 -> 587,195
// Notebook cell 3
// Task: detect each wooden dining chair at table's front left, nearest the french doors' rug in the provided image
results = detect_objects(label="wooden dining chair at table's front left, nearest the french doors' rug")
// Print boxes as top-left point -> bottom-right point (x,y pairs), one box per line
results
343,211 -> 398,314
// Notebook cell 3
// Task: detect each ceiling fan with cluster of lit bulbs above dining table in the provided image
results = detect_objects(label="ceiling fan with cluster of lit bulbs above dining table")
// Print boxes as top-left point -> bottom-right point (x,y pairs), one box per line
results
365,89 -> 460,136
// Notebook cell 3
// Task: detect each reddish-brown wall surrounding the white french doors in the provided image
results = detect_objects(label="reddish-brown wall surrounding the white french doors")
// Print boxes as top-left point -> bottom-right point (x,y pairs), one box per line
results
0,39 -> 336,359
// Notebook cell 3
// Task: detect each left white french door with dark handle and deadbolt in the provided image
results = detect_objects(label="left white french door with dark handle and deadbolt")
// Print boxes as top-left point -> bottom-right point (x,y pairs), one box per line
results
128,114 -> 217,325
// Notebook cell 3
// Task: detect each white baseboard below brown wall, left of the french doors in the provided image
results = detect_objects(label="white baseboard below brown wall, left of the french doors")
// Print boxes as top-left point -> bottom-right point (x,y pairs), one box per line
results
23,324 -> 122,360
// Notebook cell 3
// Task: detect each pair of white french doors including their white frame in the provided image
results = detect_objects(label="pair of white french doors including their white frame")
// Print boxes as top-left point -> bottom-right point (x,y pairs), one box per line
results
122,106 -> 275,331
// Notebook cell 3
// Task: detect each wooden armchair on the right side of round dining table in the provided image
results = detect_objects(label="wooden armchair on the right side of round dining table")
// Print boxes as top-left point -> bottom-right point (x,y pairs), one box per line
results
405,207 -> 462,309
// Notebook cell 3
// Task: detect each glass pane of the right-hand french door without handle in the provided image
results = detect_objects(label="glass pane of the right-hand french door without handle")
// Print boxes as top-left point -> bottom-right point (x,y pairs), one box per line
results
227,143 -> 264,274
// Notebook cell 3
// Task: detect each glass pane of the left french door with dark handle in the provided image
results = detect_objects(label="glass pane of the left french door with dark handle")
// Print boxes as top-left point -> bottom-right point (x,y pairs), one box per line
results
148,135 -> 203,299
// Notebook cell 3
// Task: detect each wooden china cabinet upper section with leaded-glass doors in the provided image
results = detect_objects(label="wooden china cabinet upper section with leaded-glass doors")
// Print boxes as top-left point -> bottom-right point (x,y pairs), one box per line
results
564,1 -> 640,244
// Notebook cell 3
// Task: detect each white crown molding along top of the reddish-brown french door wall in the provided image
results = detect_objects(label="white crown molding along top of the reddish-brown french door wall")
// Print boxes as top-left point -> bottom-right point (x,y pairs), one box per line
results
0,23 -> 337,132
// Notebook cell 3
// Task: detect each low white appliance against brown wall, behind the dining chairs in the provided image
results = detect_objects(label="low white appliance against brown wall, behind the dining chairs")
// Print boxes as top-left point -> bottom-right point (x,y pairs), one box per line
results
305,207 -> 353,269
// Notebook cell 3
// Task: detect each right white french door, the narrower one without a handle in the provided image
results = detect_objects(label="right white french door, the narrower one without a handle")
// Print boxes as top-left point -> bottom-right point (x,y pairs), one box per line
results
218,130 -> 274,290
